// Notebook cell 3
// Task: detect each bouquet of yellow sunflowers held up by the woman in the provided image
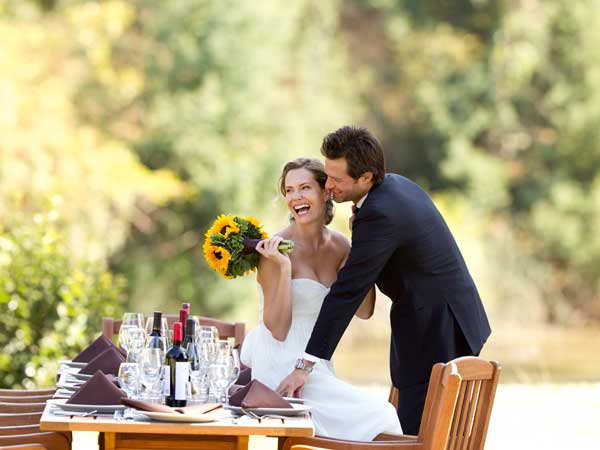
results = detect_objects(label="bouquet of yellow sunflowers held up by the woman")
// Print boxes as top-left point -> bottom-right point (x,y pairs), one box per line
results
203,214 -> 294,278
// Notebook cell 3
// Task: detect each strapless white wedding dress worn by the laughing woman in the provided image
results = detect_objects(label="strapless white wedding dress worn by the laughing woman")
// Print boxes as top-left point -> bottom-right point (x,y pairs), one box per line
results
241,278 -> 402,441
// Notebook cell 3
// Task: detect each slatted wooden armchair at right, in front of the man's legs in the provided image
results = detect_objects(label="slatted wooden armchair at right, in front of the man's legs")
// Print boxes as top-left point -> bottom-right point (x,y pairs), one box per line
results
283,356 -> 500,450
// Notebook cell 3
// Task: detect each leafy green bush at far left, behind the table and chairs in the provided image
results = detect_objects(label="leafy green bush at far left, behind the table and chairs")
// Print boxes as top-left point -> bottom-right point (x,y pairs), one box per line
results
0,210 -> 125,388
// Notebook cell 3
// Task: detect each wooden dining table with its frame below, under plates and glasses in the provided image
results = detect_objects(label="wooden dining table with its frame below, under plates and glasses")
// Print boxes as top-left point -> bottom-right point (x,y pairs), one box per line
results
40,405 -> 315,450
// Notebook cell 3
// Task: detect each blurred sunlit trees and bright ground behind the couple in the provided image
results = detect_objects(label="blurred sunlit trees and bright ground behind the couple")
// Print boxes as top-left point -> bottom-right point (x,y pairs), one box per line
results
0,0 -> 600,449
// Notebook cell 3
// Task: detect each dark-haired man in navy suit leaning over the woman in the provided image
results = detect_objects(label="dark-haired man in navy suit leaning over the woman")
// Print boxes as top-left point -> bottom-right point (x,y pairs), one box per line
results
277,126 -> 491,435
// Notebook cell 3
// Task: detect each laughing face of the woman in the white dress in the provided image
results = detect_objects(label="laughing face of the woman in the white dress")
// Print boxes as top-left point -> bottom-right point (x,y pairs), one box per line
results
285,169 -> 327,224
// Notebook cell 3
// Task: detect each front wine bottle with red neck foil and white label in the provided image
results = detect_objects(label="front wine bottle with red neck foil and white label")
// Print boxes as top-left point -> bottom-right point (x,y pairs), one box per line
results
165,322 -> 190,407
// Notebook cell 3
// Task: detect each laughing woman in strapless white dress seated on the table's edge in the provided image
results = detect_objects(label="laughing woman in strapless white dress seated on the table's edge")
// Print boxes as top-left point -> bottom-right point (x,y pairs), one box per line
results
241,158 -> 401,441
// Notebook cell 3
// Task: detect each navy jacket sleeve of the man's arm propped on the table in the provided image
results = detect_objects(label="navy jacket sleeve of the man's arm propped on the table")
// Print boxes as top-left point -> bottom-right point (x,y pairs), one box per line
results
306,210 -> 399,359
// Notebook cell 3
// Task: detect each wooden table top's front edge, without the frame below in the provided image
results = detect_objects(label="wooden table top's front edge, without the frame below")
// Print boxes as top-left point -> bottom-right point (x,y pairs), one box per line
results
40,405 -> 315,437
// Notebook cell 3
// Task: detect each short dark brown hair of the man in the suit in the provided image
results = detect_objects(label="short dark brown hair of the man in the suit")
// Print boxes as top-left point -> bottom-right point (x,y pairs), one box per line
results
321,125 -> 385,185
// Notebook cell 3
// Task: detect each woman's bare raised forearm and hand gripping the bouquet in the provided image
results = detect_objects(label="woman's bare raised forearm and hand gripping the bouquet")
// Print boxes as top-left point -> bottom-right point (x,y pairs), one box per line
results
256,236 -> 292,341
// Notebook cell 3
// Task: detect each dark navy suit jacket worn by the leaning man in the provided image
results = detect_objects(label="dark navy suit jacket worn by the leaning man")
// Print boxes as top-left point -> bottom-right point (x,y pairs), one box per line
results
306,174 -> 491,388
